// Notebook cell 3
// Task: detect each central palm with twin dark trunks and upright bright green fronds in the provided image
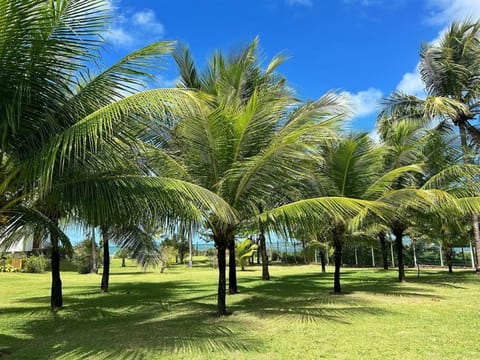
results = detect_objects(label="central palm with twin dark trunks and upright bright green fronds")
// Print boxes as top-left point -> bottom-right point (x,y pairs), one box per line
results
169,40 -> 344,315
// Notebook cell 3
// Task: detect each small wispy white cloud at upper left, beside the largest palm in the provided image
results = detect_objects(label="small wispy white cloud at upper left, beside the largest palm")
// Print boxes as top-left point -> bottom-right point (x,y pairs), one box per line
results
105,9 -> 165,49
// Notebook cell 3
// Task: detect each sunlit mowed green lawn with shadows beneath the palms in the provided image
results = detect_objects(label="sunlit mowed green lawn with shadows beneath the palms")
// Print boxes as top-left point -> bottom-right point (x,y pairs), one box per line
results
0,260 -> 480,360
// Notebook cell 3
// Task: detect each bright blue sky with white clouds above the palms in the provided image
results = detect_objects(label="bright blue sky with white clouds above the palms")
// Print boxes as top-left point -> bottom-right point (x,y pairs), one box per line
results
101,0 -> 480,130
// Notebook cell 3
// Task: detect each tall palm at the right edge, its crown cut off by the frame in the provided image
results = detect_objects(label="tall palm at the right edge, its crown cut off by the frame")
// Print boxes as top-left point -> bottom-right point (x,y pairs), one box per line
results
381,20 -> 480,274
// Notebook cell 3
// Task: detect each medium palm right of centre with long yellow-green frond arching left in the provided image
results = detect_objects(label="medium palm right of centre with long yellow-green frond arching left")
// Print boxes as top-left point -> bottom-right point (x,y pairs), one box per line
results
267,134 -> 428,293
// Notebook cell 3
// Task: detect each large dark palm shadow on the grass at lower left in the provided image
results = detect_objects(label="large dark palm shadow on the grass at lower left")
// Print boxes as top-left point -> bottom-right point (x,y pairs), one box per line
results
4,281 -> 262,359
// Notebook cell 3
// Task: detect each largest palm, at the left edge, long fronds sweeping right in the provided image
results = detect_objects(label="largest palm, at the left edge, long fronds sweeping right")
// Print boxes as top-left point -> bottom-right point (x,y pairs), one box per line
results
0,0 -> 231,309
